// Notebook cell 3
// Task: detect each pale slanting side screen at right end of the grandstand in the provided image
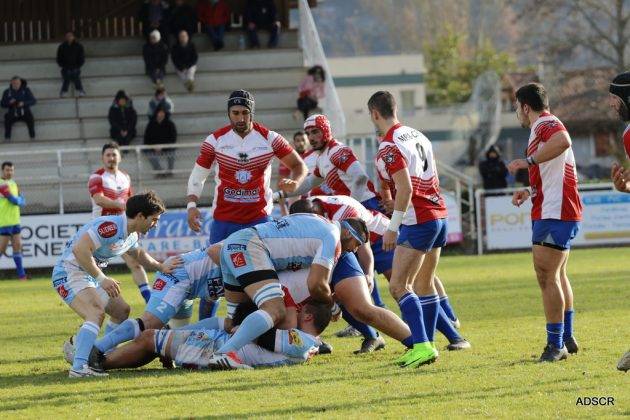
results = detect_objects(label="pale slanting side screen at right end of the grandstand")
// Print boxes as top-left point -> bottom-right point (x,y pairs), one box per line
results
298,0 -> 346,138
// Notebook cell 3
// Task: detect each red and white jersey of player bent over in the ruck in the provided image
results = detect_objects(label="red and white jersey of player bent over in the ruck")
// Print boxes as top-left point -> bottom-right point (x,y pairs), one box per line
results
311,195 -> 389,242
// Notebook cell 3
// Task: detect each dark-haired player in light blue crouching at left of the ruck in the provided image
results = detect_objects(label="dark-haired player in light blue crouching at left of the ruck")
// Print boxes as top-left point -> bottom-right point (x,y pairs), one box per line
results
52,191 -> 181,378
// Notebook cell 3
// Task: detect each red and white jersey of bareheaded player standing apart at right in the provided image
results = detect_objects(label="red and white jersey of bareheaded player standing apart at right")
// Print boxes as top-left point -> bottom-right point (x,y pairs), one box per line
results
527,112 -> 582,221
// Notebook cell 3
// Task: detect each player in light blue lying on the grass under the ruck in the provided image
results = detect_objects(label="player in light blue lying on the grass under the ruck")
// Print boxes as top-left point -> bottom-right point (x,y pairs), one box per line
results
103,292 -> 331,370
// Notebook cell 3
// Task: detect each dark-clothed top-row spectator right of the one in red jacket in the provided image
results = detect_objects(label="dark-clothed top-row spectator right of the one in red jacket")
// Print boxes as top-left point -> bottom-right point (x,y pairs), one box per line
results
243,0 -> 280,48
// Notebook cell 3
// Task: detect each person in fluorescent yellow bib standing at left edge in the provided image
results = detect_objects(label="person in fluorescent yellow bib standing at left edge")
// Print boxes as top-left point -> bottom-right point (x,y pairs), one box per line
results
0,162 -> 27,280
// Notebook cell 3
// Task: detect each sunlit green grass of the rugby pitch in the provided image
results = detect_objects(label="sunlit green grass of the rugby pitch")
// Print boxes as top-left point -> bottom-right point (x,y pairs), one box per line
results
0,249 -> 630,418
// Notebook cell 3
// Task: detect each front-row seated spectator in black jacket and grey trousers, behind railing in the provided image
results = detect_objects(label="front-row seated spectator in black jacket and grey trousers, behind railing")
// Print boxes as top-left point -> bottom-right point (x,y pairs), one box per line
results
144,107 -> 177,177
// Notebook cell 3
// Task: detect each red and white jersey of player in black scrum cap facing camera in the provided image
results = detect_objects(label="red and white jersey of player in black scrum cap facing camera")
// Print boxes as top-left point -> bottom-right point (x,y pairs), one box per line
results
197,123 -> 293,223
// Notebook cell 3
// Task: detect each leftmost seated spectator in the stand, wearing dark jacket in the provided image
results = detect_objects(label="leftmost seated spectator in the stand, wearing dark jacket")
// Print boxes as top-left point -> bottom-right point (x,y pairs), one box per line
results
0,76 -> 37,140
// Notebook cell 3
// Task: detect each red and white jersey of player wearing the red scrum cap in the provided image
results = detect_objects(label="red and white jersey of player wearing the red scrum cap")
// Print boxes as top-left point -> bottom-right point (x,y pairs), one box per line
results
313,139 -> 376,202
